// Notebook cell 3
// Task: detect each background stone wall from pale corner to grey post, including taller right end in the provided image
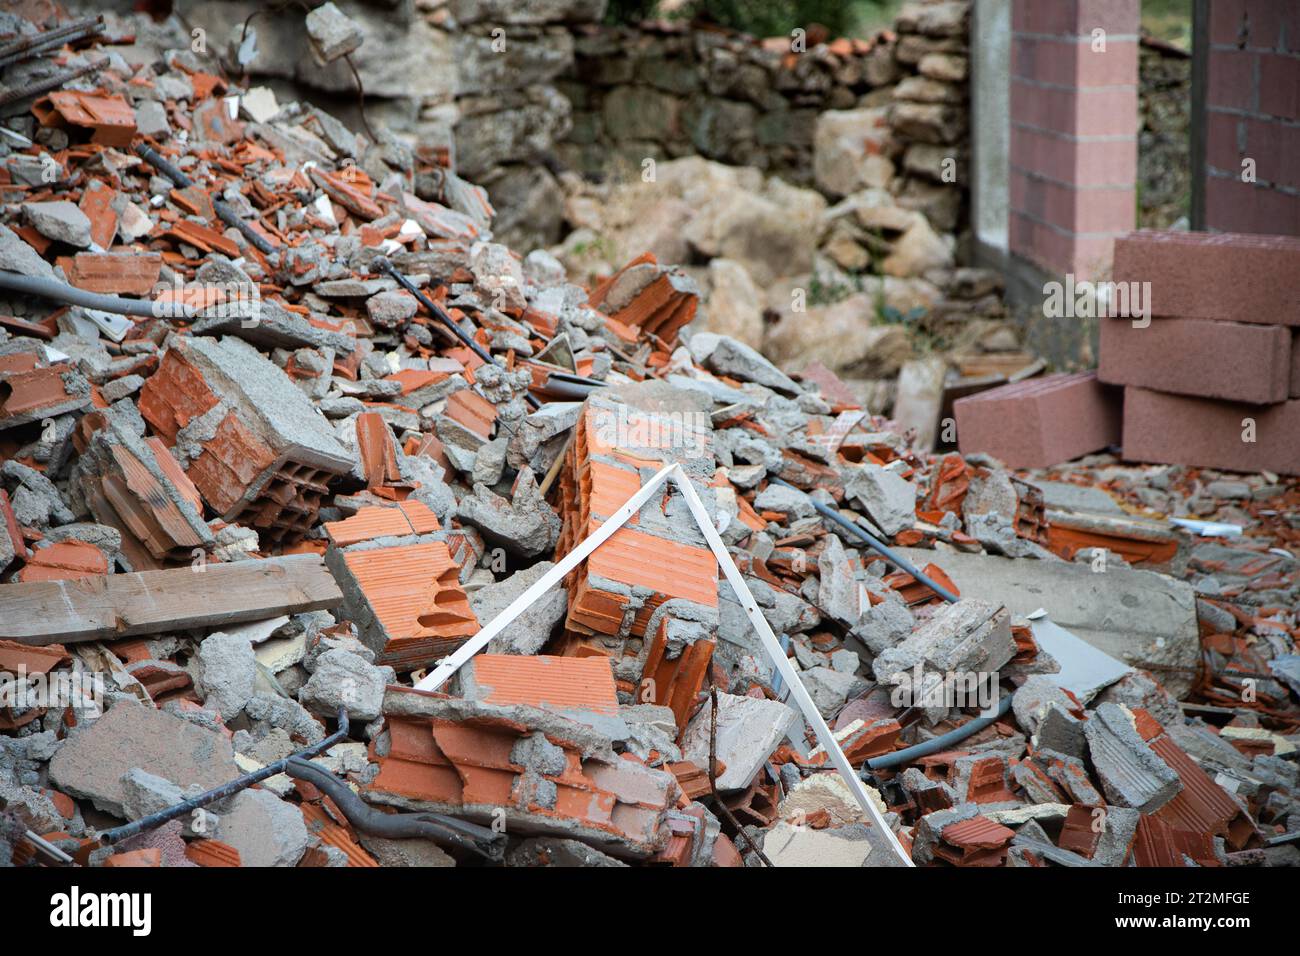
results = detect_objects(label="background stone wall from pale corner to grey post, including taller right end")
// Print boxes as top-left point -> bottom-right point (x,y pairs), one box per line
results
559,3 -> 969,239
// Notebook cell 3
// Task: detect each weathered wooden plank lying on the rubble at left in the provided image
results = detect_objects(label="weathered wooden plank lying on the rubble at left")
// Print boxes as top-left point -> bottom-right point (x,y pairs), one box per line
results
0,554 -> 343,646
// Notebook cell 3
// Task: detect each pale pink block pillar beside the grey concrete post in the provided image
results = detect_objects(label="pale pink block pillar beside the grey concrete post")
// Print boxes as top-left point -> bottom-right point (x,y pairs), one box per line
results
1009,0 -> 1139,278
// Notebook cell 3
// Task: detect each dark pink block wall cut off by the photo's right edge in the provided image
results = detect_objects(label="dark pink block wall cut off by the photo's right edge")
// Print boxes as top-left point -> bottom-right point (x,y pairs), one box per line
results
1205,0 -> 1300,235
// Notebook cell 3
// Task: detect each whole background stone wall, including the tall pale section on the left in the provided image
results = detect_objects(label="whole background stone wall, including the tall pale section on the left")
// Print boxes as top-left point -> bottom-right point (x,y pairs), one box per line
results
167,0 -> 970,248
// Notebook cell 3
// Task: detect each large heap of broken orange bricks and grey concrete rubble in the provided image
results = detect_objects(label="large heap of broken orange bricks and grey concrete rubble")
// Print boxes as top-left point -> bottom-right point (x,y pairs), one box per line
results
0,7 -> 1300,866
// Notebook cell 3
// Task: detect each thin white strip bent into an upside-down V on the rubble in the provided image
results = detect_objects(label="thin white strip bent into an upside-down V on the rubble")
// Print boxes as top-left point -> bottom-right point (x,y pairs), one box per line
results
416,463 -> 914,866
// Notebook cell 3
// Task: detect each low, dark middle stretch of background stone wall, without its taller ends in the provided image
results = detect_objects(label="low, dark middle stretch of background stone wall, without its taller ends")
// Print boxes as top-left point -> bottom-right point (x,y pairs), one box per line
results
560,22 -> 898,186
